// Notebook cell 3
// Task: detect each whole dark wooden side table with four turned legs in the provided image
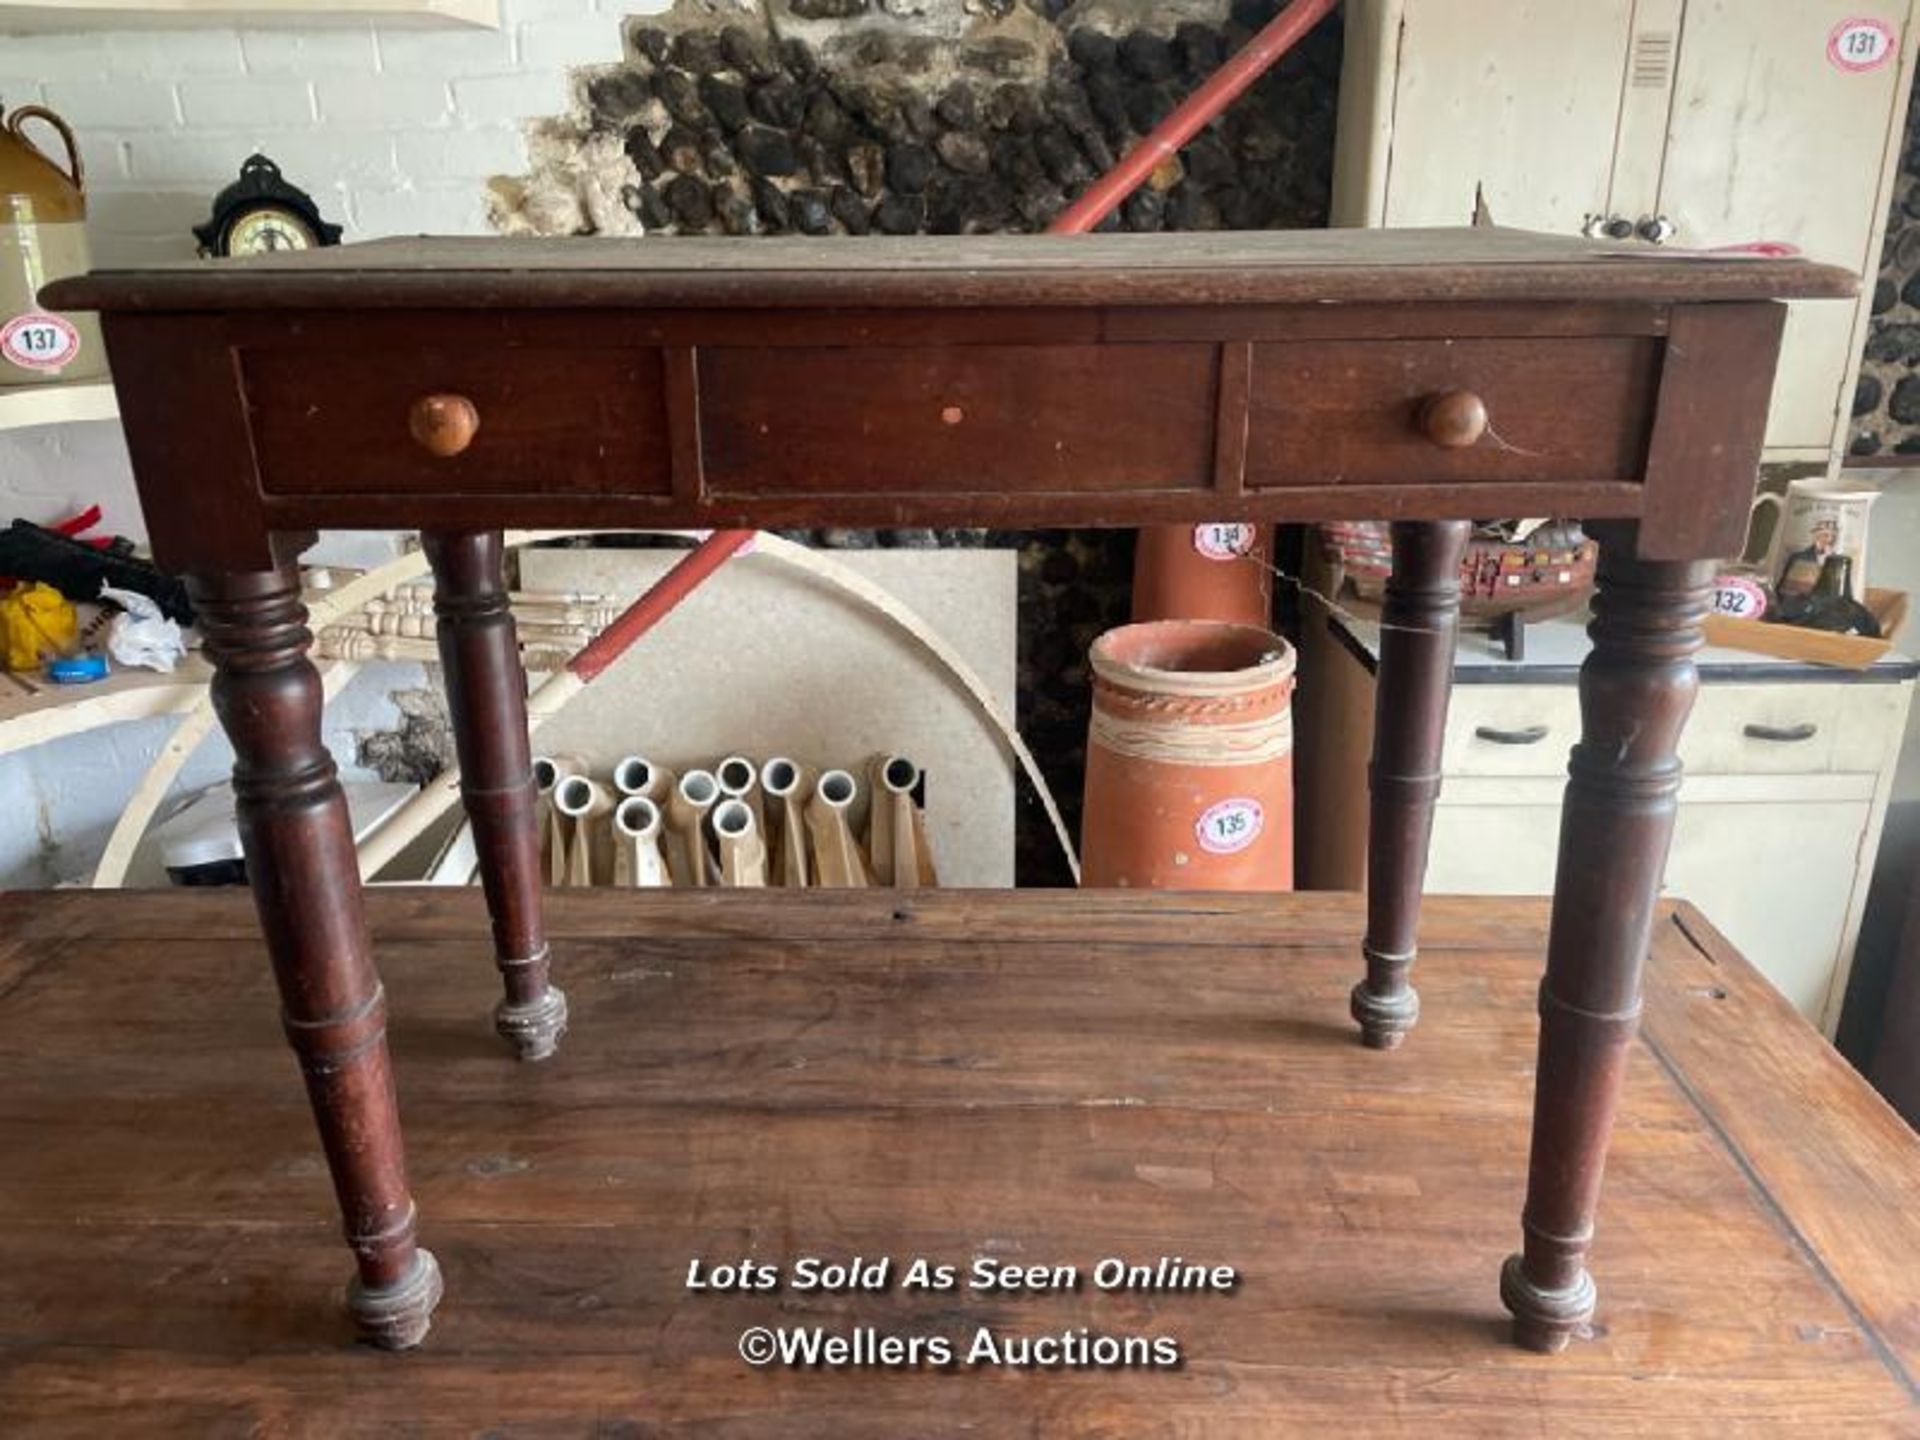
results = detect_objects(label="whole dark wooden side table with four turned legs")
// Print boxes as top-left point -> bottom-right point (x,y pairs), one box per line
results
46,230 -> 1855,1350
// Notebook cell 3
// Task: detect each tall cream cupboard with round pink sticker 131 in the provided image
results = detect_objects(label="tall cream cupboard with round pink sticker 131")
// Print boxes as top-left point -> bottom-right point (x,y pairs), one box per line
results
1332,0 -> 1920,465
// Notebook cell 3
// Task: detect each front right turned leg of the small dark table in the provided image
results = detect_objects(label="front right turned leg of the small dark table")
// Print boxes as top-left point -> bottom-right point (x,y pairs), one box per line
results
1500,526 -> 1715,1352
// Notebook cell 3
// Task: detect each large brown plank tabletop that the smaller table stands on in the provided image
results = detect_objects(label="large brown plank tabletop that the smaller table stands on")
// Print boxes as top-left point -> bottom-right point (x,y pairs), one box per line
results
0,891 -> 1920,1440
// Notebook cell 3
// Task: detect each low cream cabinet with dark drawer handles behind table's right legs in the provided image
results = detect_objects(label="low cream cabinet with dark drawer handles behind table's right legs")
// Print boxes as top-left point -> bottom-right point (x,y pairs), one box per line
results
1296,612 -> 1920,1035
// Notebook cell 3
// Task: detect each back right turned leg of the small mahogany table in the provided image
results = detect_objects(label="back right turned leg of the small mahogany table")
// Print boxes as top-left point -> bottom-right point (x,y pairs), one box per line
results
1352,520 -> 1471,1050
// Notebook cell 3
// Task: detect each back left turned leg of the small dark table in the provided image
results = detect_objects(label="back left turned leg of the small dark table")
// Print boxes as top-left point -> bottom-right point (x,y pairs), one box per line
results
422,530 -> 566,1060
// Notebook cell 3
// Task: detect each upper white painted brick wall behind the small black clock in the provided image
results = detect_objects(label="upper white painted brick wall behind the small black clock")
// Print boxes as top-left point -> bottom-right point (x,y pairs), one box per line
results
0,0 -> 664,257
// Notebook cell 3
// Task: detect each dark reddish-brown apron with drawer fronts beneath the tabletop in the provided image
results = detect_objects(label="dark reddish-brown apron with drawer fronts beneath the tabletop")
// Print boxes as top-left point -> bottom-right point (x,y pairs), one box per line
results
108,301 -> 1784,570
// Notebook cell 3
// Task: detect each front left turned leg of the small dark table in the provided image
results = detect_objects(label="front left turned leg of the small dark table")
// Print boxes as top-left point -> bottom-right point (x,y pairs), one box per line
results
188,564 -> 440,1350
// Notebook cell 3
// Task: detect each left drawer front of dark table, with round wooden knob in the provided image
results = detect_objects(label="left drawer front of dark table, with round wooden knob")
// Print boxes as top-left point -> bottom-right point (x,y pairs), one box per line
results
238,347 -> 672,495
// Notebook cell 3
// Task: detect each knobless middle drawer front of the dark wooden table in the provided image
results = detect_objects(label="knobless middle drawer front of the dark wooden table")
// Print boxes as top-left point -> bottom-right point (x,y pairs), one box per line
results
699,344 -> 1219,497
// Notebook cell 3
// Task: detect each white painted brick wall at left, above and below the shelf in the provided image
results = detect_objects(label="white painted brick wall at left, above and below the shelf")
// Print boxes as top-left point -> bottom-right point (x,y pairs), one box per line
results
0,0 -> 664,885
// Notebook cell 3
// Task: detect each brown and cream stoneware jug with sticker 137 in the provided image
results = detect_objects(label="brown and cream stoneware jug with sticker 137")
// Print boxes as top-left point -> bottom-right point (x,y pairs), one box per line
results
0,106 -> 106,386
